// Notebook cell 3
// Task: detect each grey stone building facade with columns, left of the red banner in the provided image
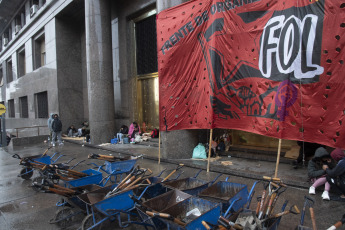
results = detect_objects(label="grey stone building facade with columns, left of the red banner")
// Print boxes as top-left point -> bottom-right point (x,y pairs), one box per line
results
0,0 -> 197,155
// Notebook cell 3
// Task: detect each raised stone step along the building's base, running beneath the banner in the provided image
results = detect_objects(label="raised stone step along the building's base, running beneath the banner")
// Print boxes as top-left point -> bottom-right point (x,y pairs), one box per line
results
64,137 -> 310,188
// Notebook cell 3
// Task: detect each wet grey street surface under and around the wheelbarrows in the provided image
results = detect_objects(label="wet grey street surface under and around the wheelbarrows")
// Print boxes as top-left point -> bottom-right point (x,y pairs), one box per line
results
0,142 -> 345,230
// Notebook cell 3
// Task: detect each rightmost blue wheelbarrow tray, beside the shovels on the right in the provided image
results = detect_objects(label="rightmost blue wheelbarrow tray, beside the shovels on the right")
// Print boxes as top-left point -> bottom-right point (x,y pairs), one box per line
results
199,181 -> 249,213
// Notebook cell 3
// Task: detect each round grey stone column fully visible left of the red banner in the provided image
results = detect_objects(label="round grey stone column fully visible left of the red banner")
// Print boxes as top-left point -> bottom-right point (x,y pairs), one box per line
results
85,0 -> 115,144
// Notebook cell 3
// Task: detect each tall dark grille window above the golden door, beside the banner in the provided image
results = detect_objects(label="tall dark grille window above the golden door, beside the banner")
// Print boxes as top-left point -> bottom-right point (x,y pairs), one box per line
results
135,14 -> 158,75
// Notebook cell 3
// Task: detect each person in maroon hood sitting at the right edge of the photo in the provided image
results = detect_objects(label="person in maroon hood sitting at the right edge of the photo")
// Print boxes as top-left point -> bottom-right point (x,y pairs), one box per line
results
322,148 -> 345,201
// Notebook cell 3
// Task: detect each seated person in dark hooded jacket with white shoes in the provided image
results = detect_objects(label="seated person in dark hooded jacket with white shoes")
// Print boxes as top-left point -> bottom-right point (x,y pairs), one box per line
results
308,147 -> 335,200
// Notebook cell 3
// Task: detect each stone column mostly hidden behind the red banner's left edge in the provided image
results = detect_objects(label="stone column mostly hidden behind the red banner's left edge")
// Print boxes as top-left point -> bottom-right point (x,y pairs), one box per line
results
156,0 -> 199,159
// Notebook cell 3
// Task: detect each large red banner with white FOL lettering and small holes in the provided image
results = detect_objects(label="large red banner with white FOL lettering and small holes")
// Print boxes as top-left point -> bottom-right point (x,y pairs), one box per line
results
157,0 -> 345,147
